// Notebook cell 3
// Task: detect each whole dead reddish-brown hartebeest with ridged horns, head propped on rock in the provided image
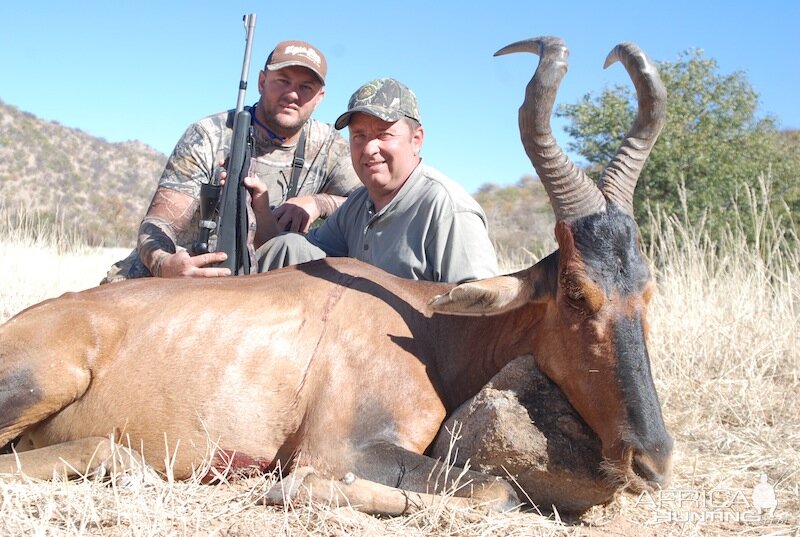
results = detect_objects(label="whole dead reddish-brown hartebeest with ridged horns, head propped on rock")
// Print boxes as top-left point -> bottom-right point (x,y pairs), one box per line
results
0,37 -> 672,514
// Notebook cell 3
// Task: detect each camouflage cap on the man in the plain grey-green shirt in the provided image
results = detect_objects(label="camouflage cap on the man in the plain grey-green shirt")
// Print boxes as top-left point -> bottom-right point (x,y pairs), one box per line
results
335,78 -> 422,130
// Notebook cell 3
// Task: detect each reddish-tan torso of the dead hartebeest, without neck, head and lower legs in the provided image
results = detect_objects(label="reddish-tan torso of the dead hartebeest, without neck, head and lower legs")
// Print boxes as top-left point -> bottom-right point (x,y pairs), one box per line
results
0,259 -> 462,477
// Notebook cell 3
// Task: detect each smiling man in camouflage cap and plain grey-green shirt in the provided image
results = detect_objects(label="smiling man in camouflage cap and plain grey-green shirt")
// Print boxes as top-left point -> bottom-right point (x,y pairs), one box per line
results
253,78 -> 498,282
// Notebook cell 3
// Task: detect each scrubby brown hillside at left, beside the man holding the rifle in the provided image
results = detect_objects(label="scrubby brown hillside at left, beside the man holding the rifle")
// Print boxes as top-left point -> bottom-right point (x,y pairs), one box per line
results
0,101 -> 166,246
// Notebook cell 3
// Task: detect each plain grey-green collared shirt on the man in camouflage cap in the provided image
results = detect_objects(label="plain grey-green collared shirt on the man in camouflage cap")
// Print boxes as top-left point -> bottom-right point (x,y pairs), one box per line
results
307,163 -> 498,283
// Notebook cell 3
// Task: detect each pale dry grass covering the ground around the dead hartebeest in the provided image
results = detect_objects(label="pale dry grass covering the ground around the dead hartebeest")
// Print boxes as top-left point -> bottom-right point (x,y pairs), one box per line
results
0,184 -> 800,536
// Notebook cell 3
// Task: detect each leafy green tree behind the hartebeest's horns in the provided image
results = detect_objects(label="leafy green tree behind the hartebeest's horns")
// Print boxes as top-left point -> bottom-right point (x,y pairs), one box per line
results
556,50 -> 800,239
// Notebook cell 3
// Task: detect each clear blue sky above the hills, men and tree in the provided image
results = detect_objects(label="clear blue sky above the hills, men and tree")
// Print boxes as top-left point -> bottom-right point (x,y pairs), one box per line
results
0,0 -> 800,192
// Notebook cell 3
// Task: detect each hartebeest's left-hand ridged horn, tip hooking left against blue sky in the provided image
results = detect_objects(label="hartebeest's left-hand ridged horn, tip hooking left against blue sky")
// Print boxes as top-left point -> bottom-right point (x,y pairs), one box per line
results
494,36 -> 606,220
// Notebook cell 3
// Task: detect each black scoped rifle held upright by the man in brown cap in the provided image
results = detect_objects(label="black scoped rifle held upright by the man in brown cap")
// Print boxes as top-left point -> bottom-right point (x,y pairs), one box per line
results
195,13 -> 256,274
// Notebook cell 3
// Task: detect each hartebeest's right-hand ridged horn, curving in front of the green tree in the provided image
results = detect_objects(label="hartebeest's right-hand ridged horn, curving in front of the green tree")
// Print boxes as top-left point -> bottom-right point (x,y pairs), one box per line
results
600,43 -> 667,216
